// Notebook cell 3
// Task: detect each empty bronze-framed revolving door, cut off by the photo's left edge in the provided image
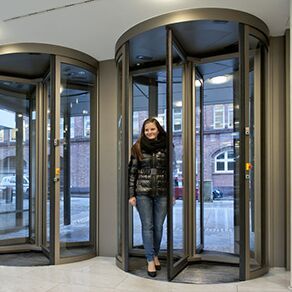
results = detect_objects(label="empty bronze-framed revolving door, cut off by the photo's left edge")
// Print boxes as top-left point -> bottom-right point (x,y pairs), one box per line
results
0,44 -> 97,264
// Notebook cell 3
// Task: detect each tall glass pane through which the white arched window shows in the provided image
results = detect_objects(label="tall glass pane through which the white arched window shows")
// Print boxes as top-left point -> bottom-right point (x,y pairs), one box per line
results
198,59 -> 238,253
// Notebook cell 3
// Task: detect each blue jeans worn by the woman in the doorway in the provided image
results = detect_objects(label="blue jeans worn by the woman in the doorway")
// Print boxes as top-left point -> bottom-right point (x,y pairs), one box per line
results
136,195 -> 167,262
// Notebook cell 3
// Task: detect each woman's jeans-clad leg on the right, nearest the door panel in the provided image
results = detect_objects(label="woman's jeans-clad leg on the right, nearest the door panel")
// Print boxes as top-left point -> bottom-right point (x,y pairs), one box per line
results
153,196 -> 167,256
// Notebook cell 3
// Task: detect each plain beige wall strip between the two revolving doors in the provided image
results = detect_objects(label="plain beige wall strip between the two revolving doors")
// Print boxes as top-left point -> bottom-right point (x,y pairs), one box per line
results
98,60 -> 117,256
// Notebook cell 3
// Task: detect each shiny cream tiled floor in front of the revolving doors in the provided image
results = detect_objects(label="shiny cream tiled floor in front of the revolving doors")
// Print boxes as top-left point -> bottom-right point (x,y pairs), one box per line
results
0,257 -> 291,292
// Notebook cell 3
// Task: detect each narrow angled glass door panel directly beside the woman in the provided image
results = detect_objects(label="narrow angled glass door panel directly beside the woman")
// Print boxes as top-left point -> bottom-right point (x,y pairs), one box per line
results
166,29 -> 187,280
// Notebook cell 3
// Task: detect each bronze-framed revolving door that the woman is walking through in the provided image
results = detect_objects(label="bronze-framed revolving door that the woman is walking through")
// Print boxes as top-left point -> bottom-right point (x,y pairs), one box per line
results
116,9 -> 268,280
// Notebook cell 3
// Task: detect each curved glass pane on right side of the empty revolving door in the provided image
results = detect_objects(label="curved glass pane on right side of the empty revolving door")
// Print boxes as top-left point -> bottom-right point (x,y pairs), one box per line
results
60,64 -> 95,257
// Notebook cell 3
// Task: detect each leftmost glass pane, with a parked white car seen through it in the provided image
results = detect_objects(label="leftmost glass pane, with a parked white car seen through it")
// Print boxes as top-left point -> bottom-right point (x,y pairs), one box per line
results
0,80 -> 35,245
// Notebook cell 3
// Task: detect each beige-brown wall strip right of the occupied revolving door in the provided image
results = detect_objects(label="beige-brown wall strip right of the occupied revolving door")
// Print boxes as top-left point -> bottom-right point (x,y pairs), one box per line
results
265,37 -> 287,267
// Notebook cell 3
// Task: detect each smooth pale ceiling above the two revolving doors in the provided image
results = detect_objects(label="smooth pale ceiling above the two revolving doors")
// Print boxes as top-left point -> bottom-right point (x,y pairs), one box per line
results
0,0 -> 289,61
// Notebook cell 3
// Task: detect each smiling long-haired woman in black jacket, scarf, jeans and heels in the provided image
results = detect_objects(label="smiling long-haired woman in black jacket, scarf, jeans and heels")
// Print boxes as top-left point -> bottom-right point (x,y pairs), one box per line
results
129,118 -> 168,277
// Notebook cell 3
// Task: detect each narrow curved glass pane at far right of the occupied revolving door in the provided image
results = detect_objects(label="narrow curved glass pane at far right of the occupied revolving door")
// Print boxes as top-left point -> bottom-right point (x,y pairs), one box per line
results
249,36 -> 263,270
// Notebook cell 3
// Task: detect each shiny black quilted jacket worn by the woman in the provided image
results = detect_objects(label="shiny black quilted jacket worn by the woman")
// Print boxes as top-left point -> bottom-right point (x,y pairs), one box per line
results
129,149 -> 168,197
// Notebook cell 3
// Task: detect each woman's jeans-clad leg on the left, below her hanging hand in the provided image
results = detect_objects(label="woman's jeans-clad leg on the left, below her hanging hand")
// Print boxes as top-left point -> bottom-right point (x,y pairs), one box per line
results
136,195 -> 154,262
